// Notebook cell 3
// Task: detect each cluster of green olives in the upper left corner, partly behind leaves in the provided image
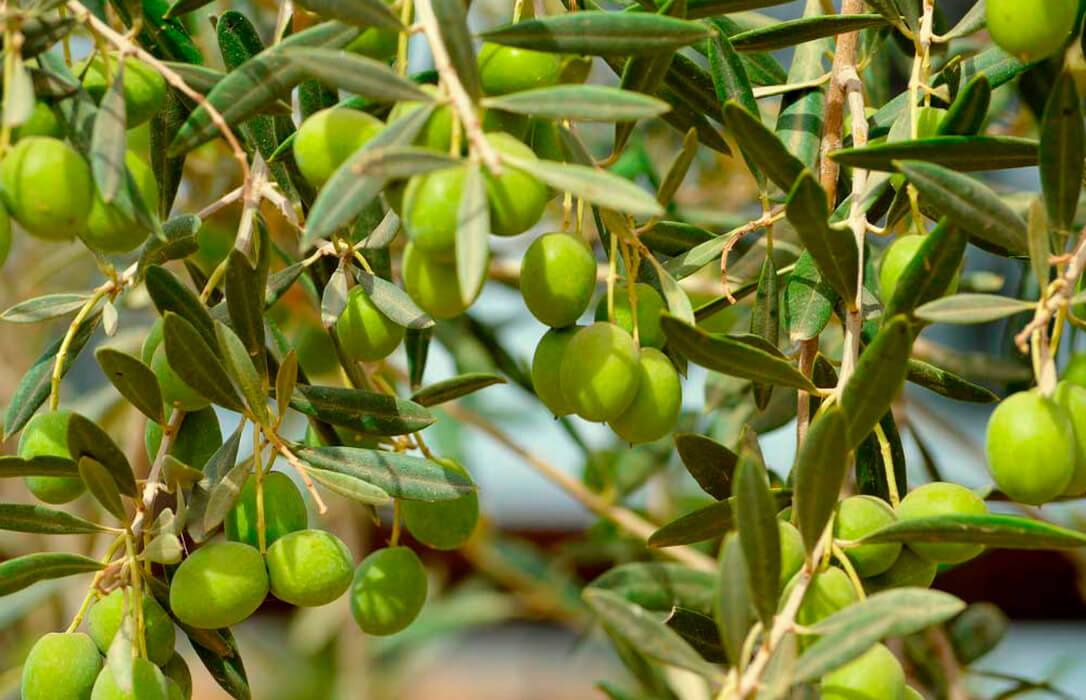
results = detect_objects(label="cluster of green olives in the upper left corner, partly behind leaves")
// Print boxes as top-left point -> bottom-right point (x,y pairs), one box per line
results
0,54 -> 166,263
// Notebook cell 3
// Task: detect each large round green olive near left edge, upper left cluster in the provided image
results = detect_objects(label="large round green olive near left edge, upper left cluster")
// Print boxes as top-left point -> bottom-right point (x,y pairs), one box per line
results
0,136 -> 94,241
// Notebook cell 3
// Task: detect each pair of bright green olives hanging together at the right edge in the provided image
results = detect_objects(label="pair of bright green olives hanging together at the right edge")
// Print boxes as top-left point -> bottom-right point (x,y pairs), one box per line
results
985,355 -> 1086,506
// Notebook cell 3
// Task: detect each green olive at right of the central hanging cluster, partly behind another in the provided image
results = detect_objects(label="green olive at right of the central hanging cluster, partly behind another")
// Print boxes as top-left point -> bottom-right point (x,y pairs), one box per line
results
607,347 -> 682,445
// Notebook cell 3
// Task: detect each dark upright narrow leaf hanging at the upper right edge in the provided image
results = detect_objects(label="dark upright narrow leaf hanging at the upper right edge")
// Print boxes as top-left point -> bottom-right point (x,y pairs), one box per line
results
1040,69 -> 1086,231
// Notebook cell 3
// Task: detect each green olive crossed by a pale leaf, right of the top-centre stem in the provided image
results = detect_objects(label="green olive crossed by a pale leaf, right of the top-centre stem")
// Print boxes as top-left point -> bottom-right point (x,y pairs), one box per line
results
484,131 -> 551,236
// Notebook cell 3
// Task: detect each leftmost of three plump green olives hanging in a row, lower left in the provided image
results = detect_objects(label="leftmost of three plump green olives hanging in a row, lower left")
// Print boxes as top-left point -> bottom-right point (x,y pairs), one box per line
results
169,542 -> 268,629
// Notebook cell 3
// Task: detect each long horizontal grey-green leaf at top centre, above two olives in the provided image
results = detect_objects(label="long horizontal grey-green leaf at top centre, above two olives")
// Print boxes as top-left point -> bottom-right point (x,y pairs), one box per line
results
481,10 -> 710,55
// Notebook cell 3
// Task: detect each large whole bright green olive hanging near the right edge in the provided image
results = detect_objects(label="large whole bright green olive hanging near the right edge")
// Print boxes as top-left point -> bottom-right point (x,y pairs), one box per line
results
985,391 -> 1076,506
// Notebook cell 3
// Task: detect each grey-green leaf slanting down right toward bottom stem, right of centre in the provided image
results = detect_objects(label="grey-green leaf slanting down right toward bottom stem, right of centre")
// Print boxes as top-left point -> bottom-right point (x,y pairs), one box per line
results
578,586 -> 722,679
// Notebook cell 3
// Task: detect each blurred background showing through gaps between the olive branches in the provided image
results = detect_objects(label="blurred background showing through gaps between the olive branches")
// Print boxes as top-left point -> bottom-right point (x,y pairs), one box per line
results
0,0 -> 1086,700
